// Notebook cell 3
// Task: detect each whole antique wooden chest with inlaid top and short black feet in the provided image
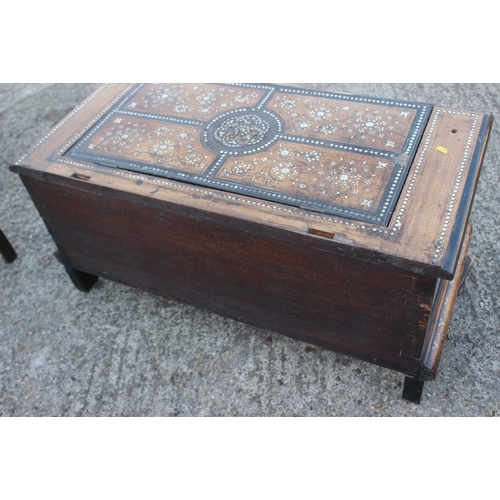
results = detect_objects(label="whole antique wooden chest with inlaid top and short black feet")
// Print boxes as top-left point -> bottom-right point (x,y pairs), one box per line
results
11,84 -> 492,402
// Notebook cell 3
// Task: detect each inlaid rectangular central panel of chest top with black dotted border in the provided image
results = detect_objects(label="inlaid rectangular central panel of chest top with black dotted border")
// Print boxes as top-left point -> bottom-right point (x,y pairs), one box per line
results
65,84 -> 432,225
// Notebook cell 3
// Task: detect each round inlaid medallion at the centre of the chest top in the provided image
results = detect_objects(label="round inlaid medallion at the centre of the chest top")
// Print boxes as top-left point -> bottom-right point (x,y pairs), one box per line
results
202,108 -> 283,156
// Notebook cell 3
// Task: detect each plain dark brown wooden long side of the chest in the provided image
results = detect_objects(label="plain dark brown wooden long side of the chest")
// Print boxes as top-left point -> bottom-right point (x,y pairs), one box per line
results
16,176 -> 436,375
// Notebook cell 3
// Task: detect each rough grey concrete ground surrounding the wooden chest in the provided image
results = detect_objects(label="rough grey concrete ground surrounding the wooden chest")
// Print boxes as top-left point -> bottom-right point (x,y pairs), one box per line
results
0,84 -> 500,417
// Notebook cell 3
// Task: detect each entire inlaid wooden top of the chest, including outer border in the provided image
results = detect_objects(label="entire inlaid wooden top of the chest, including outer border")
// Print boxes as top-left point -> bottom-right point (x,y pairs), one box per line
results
11,84 -> 492,279
